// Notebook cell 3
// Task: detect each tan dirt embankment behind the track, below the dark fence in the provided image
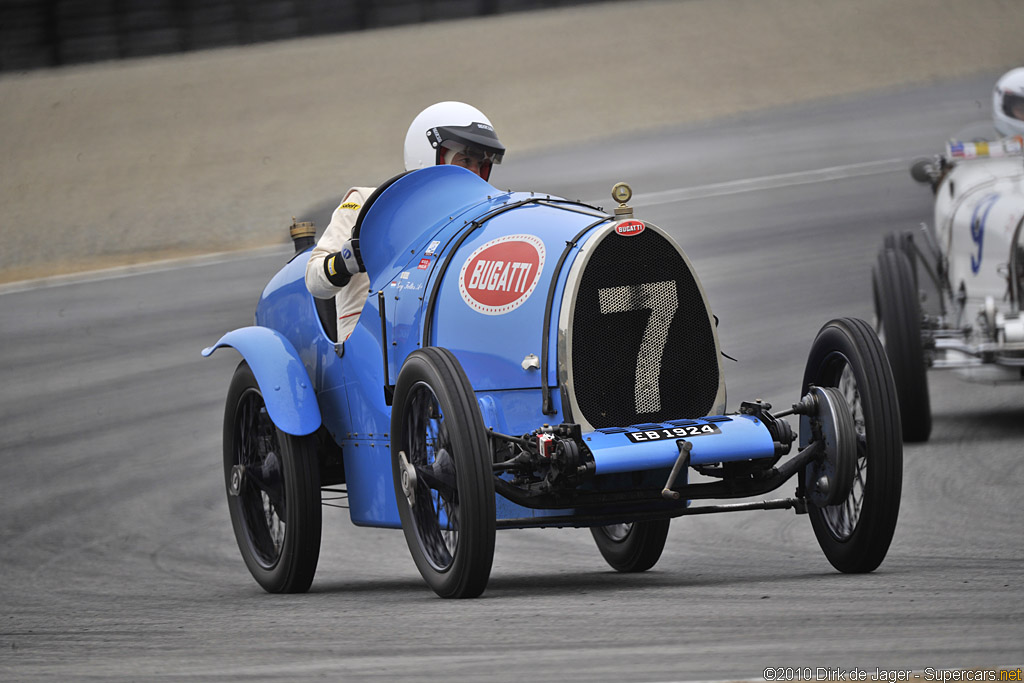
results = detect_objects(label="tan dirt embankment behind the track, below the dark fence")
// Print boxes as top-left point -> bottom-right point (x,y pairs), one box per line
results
0,0 -> 1024,282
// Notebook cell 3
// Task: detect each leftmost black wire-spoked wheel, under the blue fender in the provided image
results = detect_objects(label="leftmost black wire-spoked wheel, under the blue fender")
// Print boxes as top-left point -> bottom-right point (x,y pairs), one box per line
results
224,360 -> 322,593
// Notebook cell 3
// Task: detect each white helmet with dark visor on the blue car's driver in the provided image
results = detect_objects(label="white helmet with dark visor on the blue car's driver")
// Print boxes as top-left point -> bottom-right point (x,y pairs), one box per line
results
406,101 -> 505,180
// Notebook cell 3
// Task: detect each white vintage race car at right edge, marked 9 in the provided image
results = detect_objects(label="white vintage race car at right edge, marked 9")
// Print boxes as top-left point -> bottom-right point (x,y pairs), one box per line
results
871,136 -> 1024,441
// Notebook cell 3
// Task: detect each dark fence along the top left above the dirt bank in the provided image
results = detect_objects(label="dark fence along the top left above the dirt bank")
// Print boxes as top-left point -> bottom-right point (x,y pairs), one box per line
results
0,0 -> 597,71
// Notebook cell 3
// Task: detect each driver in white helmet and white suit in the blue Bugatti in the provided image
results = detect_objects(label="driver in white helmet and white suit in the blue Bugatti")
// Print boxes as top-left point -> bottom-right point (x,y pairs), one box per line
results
306,101 -> 505,342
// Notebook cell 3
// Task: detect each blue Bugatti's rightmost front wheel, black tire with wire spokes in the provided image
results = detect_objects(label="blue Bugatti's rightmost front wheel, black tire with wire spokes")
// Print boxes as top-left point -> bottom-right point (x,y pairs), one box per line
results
800,317 -> 903,573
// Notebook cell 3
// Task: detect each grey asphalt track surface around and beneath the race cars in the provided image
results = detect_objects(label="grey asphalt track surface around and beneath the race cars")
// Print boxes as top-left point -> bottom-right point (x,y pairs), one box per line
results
0,74 -> 1024,681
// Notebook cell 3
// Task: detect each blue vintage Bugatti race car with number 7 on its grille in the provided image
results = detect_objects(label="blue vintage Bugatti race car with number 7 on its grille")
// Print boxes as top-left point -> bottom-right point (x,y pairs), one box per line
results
203,166 -> 902,598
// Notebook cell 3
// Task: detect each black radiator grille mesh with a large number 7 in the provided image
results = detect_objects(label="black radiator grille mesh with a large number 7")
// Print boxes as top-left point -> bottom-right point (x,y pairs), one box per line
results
571,229 -> 719,428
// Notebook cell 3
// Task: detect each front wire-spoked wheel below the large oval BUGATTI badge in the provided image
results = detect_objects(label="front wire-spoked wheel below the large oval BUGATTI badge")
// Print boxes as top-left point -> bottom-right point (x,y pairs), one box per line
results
391,347 -> 496,598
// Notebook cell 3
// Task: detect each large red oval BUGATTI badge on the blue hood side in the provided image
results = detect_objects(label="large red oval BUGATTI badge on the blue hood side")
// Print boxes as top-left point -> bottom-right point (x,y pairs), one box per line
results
459,234 -> 544,315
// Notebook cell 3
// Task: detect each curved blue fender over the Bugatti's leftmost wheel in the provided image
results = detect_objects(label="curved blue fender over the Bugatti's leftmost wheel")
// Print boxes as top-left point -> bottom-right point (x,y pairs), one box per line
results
203,327 -> 321,436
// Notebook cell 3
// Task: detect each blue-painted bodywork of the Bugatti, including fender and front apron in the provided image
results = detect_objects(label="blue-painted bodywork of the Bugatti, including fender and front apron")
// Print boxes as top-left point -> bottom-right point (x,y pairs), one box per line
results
204,166 -> 775,527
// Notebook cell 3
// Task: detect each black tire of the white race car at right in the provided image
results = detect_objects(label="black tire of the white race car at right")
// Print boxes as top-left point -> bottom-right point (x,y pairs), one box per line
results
871,247 -> 932,442
